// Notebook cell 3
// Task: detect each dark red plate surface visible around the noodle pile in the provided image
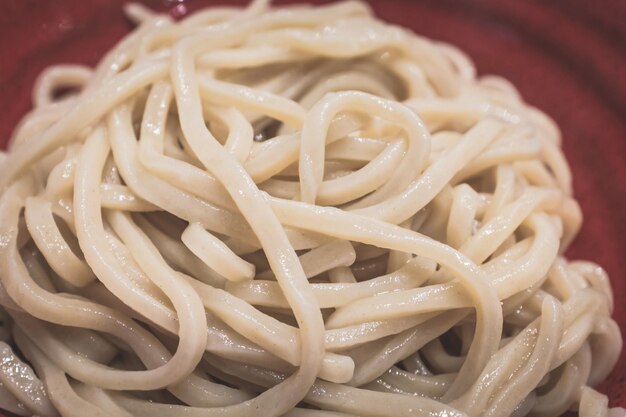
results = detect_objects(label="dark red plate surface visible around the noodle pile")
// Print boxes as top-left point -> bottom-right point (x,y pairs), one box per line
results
0,0 -> 626,416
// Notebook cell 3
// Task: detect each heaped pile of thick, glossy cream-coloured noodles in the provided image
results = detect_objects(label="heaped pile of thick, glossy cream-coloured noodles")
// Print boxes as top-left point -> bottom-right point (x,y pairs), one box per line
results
0,1 -> 626,417
